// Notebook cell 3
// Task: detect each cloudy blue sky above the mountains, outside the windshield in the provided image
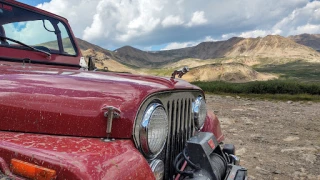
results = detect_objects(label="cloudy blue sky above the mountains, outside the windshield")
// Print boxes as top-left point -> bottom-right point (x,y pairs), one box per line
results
18,0 -> 320,50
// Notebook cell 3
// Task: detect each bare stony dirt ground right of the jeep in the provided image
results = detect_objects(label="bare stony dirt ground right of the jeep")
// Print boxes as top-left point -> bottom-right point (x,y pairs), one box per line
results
206,94 -> 320,180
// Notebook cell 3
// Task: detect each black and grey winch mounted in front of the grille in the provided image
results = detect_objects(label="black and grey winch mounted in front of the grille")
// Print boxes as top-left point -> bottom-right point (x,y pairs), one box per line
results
174,132 -> 247,180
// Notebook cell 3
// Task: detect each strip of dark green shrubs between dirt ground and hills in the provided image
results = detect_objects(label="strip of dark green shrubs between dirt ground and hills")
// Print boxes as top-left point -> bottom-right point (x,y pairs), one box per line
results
192,80 -> 320,95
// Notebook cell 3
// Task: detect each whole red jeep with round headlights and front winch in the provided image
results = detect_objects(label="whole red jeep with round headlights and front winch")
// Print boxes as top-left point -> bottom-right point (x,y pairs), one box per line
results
0,0 -> 246,180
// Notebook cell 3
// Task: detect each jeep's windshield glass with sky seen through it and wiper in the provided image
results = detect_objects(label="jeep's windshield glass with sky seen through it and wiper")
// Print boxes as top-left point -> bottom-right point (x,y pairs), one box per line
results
0,3 -> 76,55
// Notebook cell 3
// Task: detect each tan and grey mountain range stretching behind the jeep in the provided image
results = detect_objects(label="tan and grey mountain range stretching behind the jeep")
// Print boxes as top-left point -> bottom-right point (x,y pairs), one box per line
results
40,34 -> 320,82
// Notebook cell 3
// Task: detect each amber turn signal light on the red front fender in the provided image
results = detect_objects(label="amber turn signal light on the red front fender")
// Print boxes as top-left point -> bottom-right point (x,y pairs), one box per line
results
11,159 -> 56,180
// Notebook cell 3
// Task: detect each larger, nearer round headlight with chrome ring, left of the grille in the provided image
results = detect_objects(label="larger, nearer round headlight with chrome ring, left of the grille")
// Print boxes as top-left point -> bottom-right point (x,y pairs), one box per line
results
139,103 -> 168,158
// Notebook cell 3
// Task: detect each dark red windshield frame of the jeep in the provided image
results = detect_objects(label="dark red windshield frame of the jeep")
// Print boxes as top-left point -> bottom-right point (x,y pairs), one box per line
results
0,0 -> 80,57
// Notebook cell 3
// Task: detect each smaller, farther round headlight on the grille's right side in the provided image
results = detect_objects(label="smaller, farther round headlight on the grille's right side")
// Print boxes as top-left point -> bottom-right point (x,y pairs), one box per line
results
192,96 -> 207,130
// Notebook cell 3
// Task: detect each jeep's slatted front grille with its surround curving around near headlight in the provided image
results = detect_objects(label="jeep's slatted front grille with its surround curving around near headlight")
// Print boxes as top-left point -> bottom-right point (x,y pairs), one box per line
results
133,90 -> 203,179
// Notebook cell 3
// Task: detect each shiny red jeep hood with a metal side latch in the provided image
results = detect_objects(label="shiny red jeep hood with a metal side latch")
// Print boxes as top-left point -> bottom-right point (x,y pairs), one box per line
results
0,65 -> 200,138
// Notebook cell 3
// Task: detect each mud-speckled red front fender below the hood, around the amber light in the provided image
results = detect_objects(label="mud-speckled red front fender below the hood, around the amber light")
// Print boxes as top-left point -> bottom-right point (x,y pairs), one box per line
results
0,132 -> 154,180
